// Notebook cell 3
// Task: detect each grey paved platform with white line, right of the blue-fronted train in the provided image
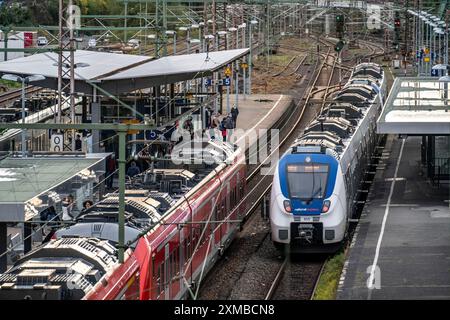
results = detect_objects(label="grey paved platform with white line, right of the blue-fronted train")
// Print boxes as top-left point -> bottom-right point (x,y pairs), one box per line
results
337,135 -> 450,300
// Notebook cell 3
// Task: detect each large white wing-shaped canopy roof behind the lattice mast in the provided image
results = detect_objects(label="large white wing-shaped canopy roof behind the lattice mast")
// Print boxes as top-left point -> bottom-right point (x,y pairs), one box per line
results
0,49 -> 249,94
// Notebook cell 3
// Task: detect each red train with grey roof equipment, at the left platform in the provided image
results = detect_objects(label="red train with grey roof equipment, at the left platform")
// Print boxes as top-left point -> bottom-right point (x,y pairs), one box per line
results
0,141 -> 246,300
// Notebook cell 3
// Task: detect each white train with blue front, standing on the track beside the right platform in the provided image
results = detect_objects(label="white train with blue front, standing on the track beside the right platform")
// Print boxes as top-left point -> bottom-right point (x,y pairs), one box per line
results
270,63 -> 386,253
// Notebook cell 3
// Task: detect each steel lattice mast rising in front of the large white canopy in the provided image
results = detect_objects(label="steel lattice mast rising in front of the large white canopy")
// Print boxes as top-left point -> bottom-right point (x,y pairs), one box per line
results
57,0 -> 79,151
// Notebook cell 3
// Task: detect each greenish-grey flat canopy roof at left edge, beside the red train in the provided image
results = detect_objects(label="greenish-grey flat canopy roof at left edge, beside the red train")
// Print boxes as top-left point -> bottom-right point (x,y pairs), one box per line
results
0,153 -> 109,222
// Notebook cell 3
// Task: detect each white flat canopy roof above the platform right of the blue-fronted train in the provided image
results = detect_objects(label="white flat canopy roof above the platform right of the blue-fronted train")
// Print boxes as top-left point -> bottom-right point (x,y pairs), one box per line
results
377,77 -> 450,135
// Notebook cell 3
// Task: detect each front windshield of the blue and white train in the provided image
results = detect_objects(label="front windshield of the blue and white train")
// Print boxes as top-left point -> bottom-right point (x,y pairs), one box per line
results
287,163 -> 329,200
